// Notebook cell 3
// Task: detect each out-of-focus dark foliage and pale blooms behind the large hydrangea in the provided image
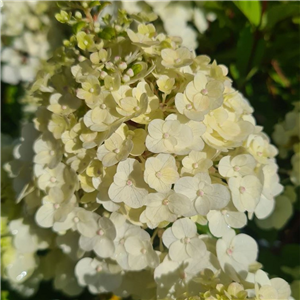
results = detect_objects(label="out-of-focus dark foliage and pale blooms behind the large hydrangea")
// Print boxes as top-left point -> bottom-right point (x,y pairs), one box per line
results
0,0 -> 300,300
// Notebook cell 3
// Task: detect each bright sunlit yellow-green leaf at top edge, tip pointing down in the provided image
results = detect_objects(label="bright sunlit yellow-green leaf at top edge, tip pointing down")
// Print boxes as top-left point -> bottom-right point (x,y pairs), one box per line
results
233,0 -> 261,27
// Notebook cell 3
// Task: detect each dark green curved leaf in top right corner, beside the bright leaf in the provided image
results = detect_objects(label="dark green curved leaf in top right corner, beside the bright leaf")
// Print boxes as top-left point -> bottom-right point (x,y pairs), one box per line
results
261,3 -> 300,30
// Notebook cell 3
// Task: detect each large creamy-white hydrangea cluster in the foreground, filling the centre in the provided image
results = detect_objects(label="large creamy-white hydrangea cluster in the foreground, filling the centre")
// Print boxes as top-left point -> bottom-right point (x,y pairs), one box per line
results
4,1 -> 290,300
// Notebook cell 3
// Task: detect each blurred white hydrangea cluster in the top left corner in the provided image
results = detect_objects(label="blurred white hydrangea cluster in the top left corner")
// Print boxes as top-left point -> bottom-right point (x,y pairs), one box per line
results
0,1 -> 58,85
